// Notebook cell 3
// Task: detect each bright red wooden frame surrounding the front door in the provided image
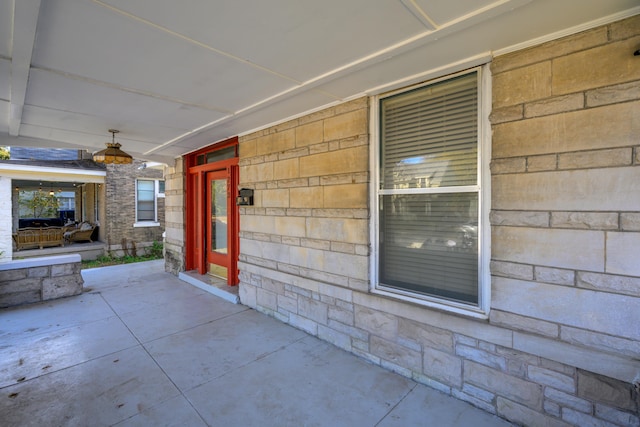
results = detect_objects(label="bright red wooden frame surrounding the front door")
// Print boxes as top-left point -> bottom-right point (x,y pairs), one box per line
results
185,137 -> 240,286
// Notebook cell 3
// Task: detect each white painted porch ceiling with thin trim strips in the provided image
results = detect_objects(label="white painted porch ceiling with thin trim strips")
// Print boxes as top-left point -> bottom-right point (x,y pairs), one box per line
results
0,0 -> 640,162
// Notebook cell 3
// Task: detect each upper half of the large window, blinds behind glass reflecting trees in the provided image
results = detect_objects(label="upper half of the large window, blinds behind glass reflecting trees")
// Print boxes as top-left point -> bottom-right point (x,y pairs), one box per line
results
380,73 -> 478,189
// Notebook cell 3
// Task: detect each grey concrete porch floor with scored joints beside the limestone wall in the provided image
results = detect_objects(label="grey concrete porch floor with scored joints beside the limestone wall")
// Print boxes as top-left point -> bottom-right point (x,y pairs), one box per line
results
0,261 -> 510,427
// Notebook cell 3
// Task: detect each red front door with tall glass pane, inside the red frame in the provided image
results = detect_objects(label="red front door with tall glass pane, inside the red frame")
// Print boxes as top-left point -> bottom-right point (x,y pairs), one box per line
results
205,169 -> 231,279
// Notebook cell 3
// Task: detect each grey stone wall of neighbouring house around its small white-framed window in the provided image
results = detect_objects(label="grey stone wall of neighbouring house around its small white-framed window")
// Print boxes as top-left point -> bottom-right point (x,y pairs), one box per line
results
101,160 -> 165,256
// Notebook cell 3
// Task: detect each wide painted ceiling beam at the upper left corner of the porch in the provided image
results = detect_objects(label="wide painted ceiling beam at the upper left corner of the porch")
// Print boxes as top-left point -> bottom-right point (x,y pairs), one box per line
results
9,0 -> 40,136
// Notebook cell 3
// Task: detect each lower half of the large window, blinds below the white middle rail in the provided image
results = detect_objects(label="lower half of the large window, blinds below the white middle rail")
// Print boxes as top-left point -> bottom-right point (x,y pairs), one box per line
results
380,193 -> 478,303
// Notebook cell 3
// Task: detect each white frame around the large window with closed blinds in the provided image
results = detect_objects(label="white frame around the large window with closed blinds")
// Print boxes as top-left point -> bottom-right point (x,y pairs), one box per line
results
369,64 -> 491,319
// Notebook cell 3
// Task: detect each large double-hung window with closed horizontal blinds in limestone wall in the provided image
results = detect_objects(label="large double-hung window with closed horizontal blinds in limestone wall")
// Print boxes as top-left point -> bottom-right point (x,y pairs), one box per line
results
374,69 -> 488,314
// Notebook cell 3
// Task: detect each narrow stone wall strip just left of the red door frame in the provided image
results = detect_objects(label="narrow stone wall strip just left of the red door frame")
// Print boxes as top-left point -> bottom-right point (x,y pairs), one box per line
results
164,159 -> 185,274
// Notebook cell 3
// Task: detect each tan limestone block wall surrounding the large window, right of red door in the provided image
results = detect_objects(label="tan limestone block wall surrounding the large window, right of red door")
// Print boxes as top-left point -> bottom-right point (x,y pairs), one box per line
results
239,13 -> 640,426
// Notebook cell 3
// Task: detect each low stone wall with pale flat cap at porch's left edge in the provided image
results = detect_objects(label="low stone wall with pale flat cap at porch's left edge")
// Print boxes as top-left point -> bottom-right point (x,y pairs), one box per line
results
0,254 -> 84,308
